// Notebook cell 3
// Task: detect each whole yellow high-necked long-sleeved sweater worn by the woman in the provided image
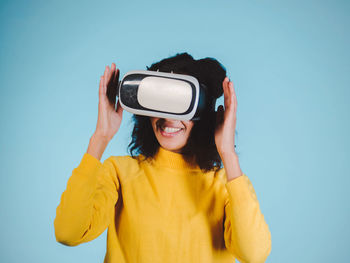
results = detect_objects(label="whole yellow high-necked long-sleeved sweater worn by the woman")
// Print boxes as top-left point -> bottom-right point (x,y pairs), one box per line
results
54,148 -> 271,263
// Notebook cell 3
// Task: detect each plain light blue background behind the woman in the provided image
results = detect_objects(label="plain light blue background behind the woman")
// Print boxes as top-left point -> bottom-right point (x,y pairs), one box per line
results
0,0 -> 350,263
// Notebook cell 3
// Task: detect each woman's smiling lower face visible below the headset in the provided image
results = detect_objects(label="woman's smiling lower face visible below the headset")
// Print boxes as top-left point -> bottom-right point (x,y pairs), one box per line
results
150,117 -> 193,153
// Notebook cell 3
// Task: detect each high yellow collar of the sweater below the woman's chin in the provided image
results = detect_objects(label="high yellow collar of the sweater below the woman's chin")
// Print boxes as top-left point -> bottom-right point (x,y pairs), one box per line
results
153,147 -> 200,170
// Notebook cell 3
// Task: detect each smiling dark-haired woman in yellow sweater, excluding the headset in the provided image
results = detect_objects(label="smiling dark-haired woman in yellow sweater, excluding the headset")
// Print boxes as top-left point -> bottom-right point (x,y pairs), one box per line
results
54,53 -> 271,263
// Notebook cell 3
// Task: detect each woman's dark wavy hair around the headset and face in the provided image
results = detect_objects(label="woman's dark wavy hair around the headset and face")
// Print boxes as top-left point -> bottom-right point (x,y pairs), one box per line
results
128,53 -> 230,171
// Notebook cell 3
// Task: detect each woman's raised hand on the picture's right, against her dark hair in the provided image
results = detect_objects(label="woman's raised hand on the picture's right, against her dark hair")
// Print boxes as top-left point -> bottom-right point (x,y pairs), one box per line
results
215,77 -> 237,159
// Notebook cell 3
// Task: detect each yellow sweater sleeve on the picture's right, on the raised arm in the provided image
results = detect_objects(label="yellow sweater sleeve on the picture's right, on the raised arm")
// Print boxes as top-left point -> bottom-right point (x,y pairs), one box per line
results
224,174 -> 271,263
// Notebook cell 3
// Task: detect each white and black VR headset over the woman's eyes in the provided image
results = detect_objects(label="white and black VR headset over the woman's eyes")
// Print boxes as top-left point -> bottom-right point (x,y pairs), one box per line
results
117,70 -> 216,120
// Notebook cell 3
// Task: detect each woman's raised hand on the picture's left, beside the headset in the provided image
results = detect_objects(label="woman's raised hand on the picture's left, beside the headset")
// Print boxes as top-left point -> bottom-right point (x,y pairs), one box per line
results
95,63 -> 123,141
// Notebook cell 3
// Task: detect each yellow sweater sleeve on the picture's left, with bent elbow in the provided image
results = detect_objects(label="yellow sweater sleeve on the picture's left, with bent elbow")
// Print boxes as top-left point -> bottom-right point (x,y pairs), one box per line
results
54,153 -> 120,246
